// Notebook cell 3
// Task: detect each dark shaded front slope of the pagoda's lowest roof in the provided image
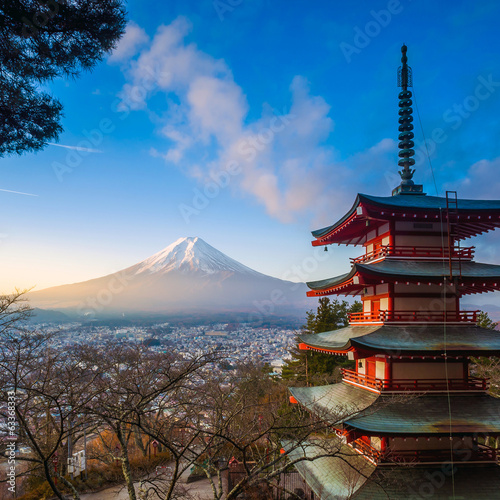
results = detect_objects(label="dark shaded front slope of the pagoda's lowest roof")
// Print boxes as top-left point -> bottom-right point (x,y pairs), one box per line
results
352,464 -> 500,500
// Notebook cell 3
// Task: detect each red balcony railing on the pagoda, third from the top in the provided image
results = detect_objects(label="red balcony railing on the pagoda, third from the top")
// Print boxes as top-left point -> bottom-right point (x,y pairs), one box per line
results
341,368 -> 489,392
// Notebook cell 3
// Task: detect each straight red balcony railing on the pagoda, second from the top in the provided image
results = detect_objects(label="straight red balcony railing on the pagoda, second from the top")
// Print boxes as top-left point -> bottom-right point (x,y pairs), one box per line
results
349,311 -> 480,325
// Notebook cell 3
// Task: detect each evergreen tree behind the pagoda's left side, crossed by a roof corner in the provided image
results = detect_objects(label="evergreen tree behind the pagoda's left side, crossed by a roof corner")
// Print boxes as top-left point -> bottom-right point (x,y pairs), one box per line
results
282,297 -> 362,385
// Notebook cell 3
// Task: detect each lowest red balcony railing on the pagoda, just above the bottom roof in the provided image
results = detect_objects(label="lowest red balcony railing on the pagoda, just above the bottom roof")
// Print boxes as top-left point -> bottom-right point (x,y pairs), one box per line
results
348,438 -> 498,465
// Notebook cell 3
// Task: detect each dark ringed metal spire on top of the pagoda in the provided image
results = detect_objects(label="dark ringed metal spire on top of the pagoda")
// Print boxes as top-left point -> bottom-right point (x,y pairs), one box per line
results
392,44 -> 424,196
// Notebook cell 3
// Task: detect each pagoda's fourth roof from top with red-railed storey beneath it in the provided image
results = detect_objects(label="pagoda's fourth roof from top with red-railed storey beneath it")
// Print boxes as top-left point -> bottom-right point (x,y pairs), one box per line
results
290,382 -> 500,465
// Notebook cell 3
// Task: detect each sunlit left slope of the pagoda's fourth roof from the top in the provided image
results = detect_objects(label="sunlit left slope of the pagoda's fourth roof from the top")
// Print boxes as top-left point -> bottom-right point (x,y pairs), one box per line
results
290,382 -> 378,425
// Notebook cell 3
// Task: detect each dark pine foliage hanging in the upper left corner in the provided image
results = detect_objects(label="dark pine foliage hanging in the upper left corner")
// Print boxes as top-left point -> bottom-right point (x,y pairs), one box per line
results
0,0 -> 125,156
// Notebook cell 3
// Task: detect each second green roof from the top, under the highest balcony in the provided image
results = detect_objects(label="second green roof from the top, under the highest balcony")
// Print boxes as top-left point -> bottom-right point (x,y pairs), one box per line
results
307,259 -> 500,290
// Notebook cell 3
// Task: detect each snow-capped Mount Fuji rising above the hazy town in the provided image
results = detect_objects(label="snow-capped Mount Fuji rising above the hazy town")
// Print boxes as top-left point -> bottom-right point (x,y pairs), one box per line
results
29,237 -> 313,319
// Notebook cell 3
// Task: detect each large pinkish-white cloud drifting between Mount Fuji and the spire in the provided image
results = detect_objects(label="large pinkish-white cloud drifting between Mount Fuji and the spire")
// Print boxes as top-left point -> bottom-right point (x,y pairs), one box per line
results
114,17 -> 397,223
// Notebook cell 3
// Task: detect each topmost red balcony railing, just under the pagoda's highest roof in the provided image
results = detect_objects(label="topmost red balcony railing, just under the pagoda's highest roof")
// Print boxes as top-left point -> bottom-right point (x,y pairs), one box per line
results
350,245 -> 475,264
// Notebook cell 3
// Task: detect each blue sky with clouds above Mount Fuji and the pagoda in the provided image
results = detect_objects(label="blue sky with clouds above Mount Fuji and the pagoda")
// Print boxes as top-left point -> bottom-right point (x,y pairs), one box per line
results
0,0 -> 500,304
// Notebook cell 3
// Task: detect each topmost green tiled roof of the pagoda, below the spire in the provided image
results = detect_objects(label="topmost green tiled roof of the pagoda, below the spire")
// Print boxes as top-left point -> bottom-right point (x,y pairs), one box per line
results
312,194 -> 500,238
